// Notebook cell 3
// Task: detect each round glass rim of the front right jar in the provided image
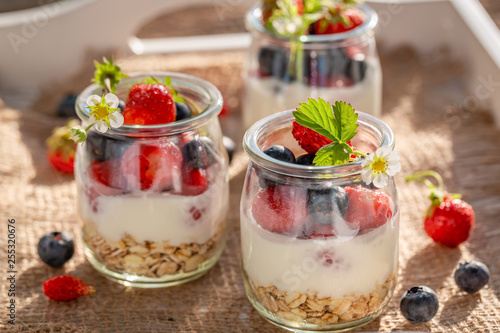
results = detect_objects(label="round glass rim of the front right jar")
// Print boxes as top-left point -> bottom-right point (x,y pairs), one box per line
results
243,110 -> 395,178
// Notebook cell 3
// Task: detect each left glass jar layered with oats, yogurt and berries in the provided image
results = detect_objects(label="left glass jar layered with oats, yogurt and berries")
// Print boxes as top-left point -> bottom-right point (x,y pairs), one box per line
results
75,72 -> 228,288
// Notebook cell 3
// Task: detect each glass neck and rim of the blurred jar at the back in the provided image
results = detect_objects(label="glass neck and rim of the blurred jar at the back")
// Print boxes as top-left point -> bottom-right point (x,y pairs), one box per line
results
245,3 -> 378,49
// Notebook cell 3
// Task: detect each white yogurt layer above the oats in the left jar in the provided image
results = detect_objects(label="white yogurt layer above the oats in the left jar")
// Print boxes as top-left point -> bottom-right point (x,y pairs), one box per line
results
78,172 -> 228,246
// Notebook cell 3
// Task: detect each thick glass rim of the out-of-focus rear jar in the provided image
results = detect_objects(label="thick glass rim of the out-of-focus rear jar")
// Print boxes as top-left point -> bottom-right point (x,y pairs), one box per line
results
245,3 -> 378,44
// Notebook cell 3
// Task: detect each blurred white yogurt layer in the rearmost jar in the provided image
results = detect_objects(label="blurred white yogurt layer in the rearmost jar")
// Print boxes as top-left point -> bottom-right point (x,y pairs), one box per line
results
243,64 -> 382,128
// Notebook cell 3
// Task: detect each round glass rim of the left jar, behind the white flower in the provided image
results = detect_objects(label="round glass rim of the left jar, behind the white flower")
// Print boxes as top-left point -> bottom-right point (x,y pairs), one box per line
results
75,71 -> 223,136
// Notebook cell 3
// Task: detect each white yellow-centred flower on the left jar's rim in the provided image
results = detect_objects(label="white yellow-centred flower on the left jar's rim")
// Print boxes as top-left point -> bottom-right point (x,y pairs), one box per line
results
87,93 -> 123,133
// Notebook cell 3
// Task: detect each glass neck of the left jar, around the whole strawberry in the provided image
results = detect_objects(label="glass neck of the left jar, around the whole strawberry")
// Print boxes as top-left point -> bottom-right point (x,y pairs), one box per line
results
75,72 -> 223,137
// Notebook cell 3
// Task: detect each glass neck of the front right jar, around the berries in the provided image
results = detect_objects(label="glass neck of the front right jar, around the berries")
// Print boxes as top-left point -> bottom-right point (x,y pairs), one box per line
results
243,110 -> 395,179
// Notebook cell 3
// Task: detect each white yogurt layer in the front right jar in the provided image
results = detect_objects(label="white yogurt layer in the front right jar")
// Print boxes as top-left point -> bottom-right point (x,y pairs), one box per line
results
241,214 -> 398,298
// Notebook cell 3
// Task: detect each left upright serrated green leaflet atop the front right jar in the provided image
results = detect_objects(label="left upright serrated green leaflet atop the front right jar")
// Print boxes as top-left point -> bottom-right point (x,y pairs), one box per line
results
293,98 -> 340,141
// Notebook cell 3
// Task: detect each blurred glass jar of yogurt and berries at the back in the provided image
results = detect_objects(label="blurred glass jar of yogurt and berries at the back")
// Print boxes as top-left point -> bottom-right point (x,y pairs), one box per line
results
243,5 -> 382,128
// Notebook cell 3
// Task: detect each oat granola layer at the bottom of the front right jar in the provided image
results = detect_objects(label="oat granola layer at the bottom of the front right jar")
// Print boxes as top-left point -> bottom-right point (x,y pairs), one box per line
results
249,274 -> 396,327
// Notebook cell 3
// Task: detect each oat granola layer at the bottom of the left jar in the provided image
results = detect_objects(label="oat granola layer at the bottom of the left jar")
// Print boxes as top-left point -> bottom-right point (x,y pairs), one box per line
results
83,222 -> 225,278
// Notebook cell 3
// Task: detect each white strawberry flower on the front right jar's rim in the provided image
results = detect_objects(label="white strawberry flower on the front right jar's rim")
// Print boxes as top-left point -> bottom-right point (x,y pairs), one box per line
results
361,146 -> 401,188
